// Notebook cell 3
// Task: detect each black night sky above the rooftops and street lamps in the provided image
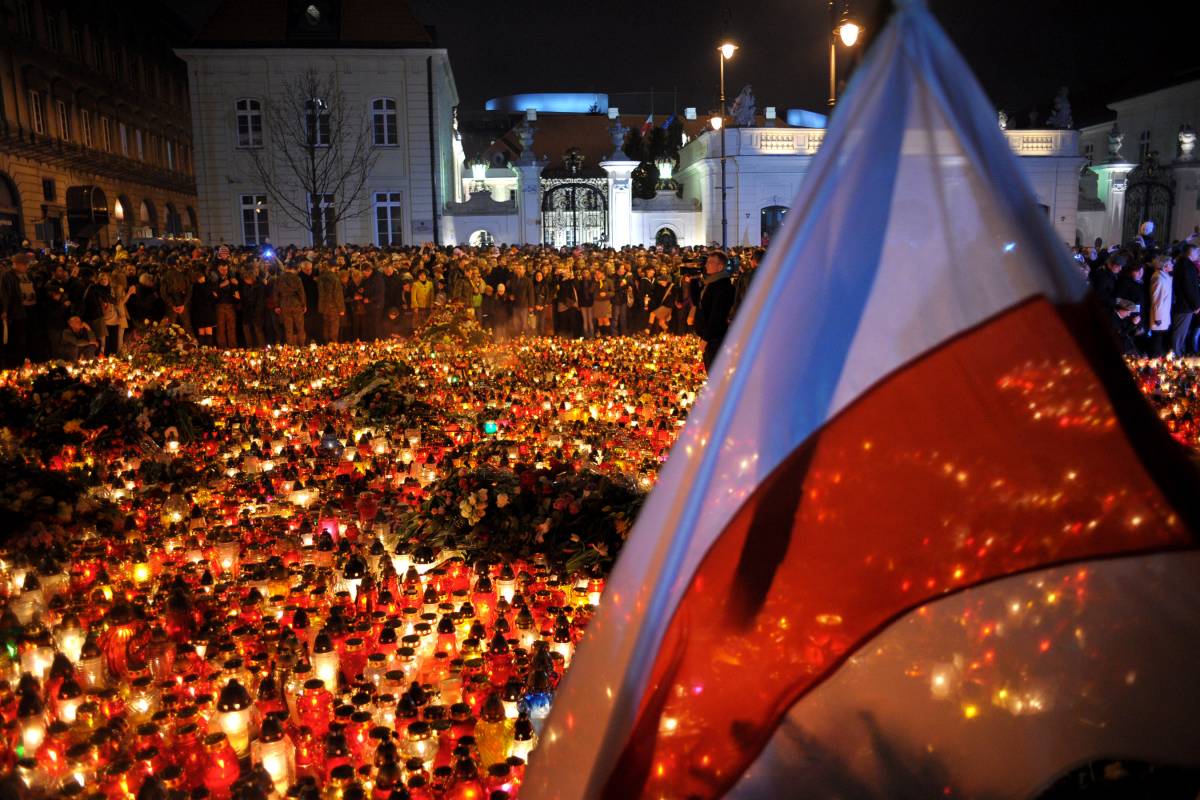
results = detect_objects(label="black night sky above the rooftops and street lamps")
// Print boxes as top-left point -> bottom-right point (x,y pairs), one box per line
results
177,0 -> 1200,127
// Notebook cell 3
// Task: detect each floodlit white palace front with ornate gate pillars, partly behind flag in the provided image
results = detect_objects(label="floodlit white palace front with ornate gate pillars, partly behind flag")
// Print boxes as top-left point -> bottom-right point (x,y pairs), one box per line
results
443,119 -> 1084,247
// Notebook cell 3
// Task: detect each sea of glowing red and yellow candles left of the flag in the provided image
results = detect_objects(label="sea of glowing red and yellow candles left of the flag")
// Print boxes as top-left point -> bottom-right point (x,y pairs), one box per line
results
0,338 -> 702,800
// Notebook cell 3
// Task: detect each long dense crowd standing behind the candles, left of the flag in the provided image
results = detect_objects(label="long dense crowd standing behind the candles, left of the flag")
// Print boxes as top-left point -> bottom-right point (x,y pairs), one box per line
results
0,243 -> 763,366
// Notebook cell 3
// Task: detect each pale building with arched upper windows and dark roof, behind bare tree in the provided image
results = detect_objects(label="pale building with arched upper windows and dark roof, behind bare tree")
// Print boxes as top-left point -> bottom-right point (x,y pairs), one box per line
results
176,0 -> 462,246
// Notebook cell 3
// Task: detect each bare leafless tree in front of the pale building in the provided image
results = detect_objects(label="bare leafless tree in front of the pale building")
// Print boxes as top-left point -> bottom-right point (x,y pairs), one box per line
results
245,70 -> 379,245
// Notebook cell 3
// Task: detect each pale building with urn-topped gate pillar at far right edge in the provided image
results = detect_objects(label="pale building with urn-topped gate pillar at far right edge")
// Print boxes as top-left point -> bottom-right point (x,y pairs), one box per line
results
1079,80 -> 1200,245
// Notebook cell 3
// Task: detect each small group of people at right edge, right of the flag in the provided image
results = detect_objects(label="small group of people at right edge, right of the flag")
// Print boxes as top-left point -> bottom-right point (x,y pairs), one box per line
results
1075,223 -> 1200,357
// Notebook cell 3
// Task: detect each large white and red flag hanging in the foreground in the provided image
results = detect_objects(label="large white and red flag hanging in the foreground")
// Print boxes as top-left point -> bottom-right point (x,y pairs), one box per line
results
522,0 -> 1200,800
